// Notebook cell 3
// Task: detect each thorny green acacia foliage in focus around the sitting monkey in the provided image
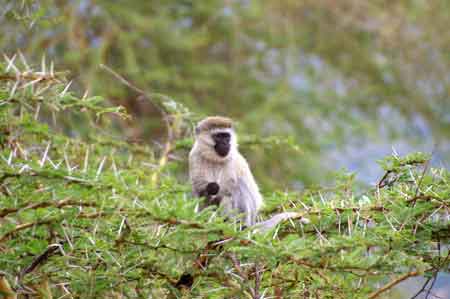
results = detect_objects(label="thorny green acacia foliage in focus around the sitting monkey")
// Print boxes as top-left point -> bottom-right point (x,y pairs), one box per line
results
0,56 -> 450,298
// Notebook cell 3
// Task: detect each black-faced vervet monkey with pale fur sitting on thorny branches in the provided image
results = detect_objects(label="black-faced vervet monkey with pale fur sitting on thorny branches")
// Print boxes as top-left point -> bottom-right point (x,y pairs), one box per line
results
189,116 -> 308,231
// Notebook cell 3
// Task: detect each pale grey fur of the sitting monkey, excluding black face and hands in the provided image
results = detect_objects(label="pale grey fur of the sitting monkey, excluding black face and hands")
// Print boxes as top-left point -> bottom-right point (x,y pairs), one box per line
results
189,117 -> 262,226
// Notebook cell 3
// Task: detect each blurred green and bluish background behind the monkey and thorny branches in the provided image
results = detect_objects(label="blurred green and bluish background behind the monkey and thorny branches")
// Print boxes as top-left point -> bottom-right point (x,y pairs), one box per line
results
0,0 -> 450,190
